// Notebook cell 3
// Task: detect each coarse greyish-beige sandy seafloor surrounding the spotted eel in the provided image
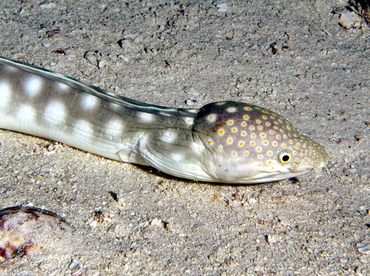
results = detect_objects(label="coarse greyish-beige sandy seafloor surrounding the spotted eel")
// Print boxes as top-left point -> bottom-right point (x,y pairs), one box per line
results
0,0 -> 370,275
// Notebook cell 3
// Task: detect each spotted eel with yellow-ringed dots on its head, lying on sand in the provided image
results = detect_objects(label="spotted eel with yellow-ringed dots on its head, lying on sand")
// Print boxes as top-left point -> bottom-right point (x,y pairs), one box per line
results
0,58 -> 328,183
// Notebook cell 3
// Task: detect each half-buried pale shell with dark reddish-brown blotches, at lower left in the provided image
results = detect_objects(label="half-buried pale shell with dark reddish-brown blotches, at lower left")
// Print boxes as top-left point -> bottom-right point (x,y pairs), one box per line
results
0,206 -> 73,260
